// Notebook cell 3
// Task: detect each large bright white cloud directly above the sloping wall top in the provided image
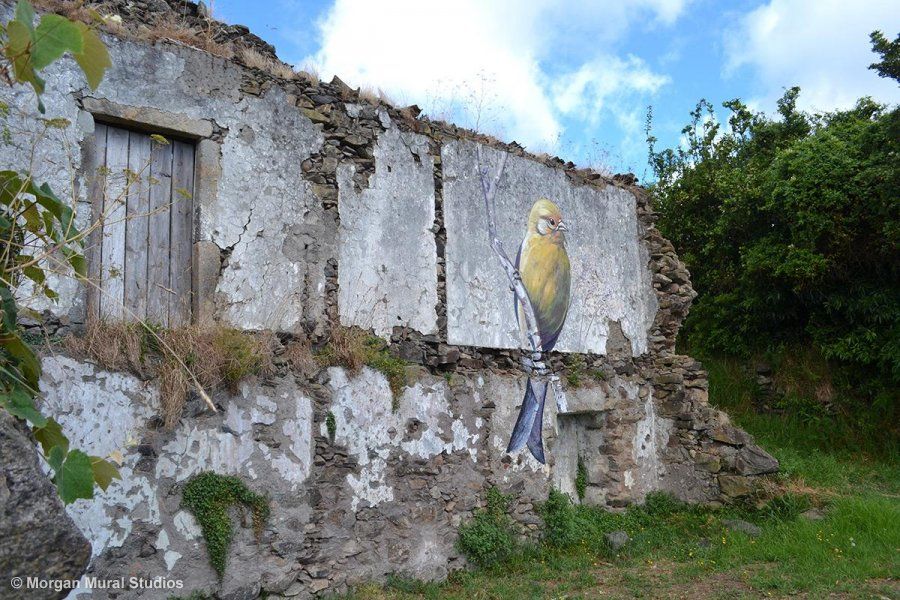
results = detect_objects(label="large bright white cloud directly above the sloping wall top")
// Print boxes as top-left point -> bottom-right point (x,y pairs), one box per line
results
309,0 -> 687,148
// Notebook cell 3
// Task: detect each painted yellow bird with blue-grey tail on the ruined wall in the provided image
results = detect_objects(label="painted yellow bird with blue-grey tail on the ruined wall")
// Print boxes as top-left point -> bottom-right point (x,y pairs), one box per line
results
506,198 -> 572,464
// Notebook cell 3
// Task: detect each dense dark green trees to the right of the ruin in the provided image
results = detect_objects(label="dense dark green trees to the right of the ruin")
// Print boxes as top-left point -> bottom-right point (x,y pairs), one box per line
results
648,79 -> 900,395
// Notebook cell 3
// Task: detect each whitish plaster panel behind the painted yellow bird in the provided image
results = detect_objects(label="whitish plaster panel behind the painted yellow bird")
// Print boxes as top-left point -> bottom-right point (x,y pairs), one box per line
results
441,141 -> 657,355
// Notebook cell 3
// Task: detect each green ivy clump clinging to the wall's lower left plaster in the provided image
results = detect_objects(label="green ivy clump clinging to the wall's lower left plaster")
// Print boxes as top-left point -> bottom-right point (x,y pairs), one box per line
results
181,471 -> 269,578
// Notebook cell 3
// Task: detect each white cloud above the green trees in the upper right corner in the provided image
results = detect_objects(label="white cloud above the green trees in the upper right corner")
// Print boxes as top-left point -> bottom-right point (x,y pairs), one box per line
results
725,0 -> 900,110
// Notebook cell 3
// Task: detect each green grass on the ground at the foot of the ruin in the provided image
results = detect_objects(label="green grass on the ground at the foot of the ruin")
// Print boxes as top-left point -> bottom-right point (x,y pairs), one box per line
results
334,360 -> 900,600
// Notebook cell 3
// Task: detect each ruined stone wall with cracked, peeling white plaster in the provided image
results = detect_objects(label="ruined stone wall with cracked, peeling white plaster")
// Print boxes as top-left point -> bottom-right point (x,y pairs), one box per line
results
0,2 -> 777,598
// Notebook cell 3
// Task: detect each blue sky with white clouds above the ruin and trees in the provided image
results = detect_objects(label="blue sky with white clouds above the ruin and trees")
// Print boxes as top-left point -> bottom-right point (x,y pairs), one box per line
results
211,0 -> 900,181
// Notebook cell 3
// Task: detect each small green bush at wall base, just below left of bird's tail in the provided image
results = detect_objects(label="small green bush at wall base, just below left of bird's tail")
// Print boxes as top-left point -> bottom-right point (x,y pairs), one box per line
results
456,487 -> 517,567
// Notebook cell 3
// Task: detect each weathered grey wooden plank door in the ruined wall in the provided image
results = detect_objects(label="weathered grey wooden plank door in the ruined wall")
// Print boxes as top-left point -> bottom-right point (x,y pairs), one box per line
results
86,123 -> 194,327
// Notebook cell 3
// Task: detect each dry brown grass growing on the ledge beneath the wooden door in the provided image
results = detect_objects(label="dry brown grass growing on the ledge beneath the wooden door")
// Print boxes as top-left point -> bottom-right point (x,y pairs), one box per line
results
65,322 -> 277,427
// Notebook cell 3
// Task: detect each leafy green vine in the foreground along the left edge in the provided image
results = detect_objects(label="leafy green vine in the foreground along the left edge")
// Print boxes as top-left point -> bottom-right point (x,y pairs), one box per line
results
0,0 -> 119,504
